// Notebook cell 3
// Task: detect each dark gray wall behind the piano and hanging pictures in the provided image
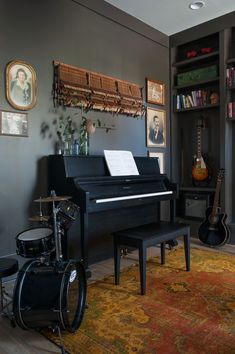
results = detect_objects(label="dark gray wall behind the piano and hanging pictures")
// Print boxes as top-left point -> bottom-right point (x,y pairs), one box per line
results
0,0 -> 170,256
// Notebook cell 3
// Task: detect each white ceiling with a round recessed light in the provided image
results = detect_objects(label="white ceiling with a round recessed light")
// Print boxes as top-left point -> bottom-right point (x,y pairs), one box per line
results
105,0 -> 235,36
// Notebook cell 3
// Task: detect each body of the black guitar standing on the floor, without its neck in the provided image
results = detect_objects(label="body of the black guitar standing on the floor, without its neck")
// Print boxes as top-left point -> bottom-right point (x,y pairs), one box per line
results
198,207 -> 229,247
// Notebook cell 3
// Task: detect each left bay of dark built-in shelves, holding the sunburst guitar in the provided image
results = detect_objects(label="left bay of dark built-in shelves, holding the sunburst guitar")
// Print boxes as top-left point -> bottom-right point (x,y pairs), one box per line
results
171,33 -> 221,227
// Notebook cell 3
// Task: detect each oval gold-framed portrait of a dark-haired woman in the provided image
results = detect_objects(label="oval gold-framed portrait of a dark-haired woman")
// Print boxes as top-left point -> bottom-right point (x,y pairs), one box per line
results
6,60 -> 36,111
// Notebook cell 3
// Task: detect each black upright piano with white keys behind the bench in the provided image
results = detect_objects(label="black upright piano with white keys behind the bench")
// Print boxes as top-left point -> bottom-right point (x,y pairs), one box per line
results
49,155 -> 178,269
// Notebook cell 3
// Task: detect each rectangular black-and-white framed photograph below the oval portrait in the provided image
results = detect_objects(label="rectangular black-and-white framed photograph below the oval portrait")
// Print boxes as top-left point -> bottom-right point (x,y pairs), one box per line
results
0,111 -> 28,136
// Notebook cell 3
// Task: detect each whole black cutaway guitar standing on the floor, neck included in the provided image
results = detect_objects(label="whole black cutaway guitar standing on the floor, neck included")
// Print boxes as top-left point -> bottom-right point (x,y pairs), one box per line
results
198,169 -> 230,247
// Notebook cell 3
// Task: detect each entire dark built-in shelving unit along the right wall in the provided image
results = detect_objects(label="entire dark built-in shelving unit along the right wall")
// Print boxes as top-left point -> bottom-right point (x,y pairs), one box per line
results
171,27 -> 235,243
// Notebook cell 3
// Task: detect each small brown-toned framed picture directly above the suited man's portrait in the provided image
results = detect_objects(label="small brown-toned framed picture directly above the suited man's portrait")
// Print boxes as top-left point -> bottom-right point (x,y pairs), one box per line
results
146,79 -> 165,106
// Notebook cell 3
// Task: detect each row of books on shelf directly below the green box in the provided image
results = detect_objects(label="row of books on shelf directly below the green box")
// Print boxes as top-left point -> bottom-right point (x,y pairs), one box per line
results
176,90 -> 218,109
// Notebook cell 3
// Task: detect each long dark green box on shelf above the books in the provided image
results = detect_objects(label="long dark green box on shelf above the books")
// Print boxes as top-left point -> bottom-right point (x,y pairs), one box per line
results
177,65 -> 218,85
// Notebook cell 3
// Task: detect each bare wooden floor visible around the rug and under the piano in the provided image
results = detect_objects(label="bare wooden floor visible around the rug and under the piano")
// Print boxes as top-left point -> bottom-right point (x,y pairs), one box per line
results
0,239 -> 235,354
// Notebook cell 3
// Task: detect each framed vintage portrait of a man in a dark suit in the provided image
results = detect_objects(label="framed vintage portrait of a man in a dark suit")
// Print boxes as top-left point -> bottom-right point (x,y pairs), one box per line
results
146,107 -> 166,147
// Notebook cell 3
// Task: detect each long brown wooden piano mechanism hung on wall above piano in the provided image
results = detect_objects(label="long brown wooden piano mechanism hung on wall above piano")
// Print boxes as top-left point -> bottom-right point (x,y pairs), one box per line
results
53,61 -> 146,117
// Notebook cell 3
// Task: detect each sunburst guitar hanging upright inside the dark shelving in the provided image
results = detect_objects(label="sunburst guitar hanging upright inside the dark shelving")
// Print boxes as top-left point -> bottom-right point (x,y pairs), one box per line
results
192,120 -> 209,183
